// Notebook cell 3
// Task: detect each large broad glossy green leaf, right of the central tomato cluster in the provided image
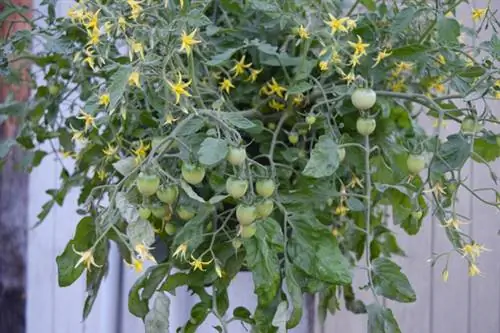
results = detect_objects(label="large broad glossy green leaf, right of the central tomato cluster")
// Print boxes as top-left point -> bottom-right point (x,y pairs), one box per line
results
288,213 -> 352,284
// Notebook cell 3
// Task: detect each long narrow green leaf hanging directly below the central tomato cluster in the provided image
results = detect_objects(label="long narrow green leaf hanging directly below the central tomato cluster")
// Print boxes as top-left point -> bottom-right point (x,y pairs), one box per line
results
243,223 -> 280,306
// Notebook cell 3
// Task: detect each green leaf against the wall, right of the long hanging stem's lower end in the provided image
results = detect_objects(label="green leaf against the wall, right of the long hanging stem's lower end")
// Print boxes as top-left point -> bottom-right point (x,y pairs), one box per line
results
372,257 -> 417,303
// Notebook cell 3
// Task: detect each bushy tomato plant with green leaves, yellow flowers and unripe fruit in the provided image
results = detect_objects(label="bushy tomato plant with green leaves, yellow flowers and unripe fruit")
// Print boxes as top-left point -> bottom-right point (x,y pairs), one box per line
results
0,0 -> 500,333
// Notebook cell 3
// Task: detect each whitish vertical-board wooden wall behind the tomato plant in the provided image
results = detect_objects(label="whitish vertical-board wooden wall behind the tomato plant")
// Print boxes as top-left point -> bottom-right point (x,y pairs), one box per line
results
27,0 -> 500,333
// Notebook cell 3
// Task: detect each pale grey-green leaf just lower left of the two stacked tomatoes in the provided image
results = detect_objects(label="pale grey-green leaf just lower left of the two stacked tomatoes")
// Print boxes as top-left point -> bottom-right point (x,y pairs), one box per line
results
302,135 -> 339,178
